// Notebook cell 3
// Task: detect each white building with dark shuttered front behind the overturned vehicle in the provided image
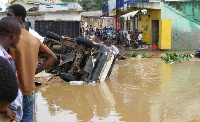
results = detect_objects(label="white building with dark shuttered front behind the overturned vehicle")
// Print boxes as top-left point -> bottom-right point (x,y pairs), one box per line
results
0,0 -> 83,38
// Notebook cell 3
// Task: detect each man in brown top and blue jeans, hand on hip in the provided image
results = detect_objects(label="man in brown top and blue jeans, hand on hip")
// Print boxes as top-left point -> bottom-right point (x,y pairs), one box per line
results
7,4 -> 57,122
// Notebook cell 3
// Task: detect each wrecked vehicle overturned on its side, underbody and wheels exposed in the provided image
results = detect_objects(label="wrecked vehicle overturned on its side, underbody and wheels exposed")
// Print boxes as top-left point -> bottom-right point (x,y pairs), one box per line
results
43,32 -> 119,83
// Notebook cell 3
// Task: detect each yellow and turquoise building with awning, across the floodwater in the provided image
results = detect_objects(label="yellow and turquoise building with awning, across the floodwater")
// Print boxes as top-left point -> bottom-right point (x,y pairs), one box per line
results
103,0 -> 200,50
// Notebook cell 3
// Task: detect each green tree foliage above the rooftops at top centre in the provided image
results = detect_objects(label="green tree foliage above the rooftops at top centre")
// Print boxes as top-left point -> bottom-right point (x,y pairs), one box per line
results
61,0 -> 108,11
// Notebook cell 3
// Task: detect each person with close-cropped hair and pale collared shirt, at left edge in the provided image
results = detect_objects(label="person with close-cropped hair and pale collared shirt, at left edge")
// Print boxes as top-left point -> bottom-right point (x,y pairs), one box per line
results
0,17 -> 23,122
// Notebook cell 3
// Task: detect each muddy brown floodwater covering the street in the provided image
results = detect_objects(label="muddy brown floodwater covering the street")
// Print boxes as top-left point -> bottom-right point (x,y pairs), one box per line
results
35,52 -> 200,122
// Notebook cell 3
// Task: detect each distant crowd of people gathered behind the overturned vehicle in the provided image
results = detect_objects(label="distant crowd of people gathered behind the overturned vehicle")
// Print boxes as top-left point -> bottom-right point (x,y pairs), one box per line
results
81,25 -> 144,49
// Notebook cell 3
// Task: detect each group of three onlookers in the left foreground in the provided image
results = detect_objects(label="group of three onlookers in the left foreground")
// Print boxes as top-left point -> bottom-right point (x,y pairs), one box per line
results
0,4 -> 57,122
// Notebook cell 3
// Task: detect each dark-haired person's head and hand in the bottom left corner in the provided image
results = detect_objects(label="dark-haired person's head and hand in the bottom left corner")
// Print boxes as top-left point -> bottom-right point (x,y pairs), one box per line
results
0,57 -> 18,122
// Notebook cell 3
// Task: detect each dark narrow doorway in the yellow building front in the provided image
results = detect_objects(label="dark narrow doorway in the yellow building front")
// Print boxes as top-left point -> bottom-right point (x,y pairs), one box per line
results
151,20 -> 159,45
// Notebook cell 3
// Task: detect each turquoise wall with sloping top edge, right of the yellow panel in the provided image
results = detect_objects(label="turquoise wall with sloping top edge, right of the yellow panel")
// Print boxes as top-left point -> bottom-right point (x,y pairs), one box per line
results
161,3 -> 200,50
